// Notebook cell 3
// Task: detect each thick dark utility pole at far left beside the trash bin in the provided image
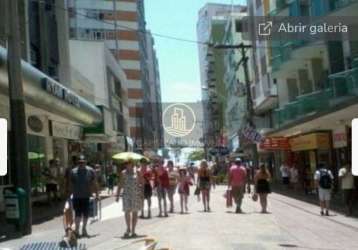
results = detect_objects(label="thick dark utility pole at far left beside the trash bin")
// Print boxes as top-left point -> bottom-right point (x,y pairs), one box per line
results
3,0 -> 32,235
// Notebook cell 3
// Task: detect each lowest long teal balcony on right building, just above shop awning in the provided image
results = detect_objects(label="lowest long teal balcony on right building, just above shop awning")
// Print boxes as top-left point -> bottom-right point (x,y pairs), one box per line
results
274,68 -> 358,128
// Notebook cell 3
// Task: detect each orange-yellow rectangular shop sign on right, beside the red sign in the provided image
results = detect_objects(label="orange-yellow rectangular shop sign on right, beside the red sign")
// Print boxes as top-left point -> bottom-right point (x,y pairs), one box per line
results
290,133 -> 331,151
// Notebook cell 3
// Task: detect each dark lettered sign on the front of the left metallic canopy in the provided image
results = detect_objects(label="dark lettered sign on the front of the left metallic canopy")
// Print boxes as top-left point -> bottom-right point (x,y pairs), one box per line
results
42,78 -> 80,107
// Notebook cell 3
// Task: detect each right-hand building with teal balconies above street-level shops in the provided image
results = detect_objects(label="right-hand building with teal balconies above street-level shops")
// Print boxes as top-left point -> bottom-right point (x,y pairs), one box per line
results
260,0 -> 358,180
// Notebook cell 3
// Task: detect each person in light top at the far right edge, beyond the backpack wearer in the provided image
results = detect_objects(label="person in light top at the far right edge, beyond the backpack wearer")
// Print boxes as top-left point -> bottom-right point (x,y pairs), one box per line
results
338,162 -> 354,216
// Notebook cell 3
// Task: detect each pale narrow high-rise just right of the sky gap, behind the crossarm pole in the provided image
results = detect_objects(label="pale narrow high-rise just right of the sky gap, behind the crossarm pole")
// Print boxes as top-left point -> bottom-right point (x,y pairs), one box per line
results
197,3 -> 245,156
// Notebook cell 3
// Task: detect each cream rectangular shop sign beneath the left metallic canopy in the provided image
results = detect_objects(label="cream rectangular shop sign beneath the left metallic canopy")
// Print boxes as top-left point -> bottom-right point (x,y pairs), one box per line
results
50,121 -> 82,140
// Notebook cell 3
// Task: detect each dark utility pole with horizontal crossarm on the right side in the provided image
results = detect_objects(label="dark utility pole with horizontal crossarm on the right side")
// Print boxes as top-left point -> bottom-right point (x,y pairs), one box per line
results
214,43 -> 259,168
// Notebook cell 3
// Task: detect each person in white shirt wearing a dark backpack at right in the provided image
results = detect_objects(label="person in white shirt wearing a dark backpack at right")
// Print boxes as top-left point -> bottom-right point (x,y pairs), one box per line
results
314,163 -> 334,216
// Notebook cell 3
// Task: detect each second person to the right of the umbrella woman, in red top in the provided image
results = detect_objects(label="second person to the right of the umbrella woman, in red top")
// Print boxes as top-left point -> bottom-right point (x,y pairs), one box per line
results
155,162 -> 169,217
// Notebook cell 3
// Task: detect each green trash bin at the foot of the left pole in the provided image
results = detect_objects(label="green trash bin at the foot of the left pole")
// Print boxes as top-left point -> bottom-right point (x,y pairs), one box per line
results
4,188 -> 27,226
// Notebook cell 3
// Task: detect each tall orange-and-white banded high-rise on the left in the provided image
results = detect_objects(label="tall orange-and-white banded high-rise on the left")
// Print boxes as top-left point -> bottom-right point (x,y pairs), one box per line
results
69,0 -> 149,148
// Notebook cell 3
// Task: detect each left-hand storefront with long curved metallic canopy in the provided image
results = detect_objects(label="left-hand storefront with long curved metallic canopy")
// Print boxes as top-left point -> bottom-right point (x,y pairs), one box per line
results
0,47 -> 102,211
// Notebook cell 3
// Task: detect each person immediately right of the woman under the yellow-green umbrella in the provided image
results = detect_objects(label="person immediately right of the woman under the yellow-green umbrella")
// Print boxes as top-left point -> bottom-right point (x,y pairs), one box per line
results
140,159 -> 153,219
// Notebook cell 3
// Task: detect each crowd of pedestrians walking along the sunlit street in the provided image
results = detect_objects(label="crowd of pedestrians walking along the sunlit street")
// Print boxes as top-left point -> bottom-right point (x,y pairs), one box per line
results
61,152 -> 354,242
